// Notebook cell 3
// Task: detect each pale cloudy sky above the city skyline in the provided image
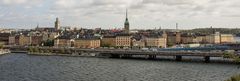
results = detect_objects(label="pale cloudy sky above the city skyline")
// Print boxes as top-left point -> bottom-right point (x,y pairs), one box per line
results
0,0 -> 240,29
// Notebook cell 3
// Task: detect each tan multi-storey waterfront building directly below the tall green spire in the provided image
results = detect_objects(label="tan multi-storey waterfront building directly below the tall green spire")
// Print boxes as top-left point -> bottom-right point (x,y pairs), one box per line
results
116,34 -> 131,47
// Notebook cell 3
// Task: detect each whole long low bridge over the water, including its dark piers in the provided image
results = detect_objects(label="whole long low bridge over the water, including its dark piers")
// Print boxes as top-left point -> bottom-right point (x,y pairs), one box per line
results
10,47 -> 239,62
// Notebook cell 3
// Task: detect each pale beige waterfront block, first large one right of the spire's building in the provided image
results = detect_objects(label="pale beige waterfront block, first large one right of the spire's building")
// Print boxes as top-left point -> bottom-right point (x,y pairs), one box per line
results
146,37 -> 167,48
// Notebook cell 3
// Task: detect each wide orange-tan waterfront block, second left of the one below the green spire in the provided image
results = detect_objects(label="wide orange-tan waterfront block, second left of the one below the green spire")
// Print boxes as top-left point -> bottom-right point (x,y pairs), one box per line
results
74,38 -> 100,48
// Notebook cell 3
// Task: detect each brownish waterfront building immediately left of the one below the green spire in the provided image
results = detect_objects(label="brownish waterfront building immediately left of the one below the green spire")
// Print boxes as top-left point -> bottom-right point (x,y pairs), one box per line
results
101,36 -> 116,47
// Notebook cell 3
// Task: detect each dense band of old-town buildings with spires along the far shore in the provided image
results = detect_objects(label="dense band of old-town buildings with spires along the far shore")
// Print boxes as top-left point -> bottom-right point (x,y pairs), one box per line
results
0,10 -> 235,49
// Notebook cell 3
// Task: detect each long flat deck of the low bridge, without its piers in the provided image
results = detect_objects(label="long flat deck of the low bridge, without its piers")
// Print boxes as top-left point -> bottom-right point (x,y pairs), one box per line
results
9,48 -> 232,57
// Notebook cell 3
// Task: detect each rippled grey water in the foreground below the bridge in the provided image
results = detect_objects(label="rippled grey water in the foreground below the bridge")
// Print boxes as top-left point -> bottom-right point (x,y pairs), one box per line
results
0,54 -> 240,81
